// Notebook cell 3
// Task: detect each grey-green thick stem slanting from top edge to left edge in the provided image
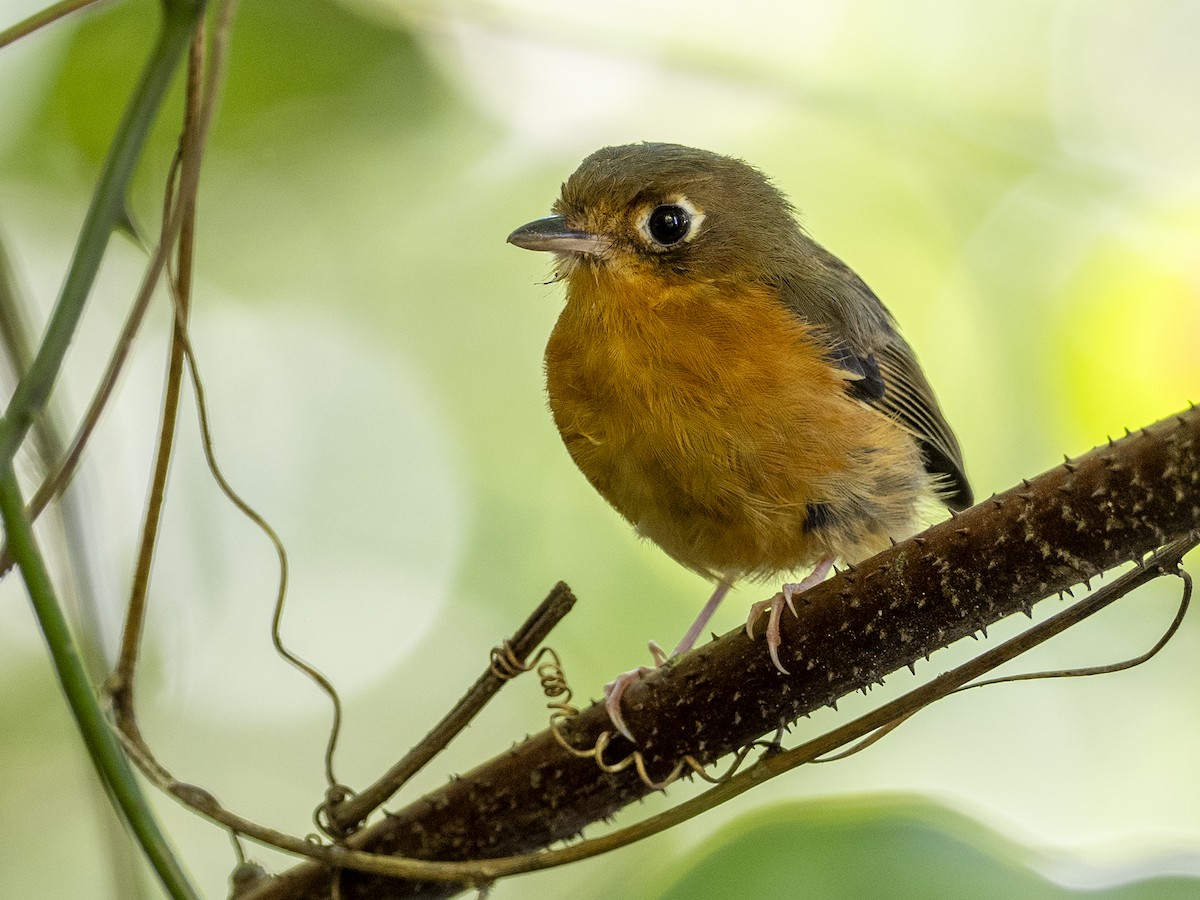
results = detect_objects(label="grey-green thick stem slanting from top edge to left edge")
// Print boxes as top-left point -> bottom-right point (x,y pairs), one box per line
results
0,0 -> 204,461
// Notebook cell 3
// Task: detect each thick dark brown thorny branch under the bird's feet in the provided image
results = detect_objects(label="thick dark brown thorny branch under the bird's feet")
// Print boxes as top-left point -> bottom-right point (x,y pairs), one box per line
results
238,408 -> 1200,900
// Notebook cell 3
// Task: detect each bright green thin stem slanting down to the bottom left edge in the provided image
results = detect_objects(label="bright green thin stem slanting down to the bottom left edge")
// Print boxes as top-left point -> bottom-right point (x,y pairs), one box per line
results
0,460 -> 199,900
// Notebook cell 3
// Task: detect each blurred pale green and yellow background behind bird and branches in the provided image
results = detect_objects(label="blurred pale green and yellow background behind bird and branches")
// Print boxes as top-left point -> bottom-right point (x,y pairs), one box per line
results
0,0 -> 1200,900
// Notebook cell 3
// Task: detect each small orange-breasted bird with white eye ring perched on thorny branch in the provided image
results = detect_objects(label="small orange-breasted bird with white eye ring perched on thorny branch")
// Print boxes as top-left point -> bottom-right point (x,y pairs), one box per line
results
508,143 -> 973,743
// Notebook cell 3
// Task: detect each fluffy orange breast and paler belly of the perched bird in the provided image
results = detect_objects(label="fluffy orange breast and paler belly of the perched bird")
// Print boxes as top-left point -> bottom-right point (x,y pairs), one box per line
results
546,265 -> 931,577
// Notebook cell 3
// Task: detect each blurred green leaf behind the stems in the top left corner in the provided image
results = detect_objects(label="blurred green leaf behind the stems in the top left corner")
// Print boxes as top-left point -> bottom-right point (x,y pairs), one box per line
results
0,0 -> 445,175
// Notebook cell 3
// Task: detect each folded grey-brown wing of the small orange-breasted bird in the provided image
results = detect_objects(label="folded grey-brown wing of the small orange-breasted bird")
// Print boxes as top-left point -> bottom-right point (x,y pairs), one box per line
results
779,236 -> 973,510
